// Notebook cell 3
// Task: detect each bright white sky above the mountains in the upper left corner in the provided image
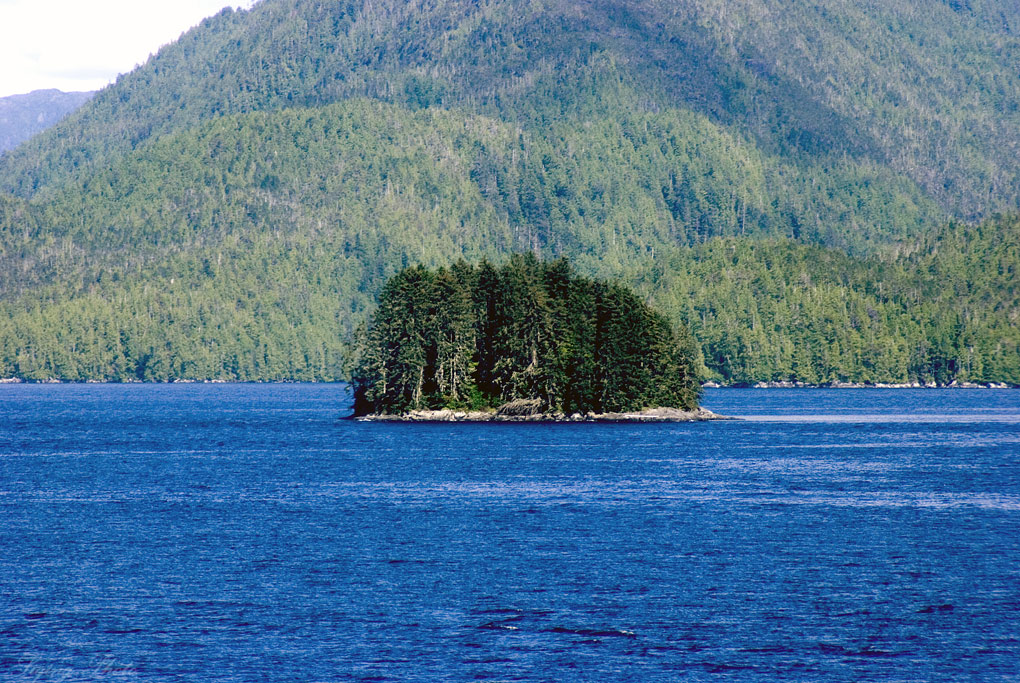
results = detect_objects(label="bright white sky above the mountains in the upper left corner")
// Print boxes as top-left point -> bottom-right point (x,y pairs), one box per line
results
0,0 -> 252,97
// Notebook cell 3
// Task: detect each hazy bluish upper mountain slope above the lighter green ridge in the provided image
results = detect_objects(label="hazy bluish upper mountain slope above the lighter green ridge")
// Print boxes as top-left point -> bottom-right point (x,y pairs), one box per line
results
0,0 -> 1020,224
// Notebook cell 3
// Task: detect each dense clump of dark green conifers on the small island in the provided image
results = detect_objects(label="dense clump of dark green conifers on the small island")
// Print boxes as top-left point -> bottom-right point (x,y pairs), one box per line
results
353,254 -> 700,415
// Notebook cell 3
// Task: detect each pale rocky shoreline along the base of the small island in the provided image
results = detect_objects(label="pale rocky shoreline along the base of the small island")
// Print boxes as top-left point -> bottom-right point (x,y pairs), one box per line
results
354,406 -> 734,422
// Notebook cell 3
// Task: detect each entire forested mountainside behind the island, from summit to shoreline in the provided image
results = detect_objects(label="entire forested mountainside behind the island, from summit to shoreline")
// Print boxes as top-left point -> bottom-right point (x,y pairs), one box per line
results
0,0 -> 1020,382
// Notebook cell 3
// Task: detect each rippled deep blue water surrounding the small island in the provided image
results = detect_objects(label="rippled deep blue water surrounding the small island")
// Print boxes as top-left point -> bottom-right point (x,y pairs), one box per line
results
0,385 -> 1020,682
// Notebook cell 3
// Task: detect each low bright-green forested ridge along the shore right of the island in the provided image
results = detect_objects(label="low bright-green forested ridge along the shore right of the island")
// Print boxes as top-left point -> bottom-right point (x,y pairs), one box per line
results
635,222 -> 1020,384
